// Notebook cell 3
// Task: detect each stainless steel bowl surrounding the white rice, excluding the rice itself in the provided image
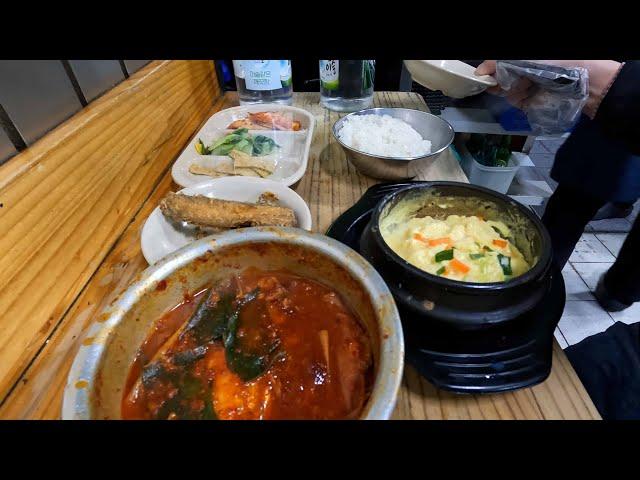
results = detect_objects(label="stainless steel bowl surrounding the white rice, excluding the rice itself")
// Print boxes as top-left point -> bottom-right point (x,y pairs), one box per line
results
333,108 -> 455,180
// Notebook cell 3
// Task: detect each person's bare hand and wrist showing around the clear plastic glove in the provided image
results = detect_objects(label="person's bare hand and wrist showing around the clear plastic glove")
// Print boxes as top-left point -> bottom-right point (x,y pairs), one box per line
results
475,60 -> 622,118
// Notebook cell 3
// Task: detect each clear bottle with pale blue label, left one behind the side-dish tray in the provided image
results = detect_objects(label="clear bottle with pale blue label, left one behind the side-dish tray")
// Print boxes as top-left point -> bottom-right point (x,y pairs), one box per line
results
233,60 -> 293,105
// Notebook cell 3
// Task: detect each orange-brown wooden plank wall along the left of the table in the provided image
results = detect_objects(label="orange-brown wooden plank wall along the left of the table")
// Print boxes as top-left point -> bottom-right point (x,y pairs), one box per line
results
0,61 -> 222,403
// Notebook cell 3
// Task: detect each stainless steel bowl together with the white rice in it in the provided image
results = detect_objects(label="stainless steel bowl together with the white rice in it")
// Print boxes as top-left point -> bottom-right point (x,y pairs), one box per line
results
333,108 -> 454,180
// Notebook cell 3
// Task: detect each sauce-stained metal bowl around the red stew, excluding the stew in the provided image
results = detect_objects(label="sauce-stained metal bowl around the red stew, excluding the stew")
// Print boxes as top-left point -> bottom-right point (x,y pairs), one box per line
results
62,227 -> 404,420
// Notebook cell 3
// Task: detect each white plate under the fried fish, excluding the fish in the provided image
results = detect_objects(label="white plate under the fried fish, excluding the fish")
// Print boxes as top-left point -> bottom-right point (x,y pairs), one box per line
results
140,177 -> 312,264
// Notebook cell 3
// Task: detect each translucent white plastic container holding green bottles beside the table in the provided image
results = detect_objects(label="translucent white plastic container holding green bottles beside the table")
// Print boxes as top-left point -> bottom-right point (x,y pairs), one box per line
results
456,143 -> 527,193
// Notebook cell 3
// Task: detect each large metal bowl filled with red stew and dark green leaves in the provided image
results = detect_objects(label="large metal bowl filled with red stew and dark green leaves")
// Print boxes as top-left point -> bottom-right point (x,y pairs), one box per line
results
62,227 -> 404,420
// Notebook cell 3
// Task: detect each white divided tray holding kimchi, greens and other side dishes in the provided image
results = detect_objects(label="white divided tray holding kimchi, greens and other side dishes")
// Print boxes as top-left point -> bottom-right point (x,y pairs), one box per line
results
171,104 -> 315,187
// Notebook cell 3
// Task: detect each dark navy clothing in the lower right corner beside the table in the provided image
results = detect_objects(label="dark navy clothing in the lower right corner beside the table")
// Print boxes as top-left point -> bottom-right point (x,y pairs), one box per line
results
565,322 -> 640,420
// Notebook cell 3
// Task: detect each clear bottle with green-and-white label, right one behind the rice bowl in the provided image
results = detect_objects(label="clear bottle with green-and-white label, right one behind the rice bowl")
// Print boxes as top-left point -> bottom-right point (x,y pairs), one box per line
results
320,60 -> 375,112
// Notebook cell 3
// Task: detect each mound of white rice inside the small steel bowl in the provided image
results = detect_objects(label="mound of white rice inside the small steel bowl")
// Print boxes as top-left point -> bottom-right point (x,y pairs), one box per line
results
338,115 -> 431,157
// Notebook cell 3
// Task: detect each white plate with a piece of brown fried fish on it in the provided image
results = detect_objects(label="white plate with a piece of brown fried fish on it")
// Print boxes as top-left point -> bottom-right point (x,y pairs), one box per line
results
141,176 -> 312,264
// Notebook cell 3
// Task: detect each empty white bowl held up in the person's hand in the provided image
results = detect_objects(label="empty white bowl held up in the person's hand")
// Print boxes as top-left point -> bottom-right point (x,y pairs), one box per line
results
404,60 -> 498,98
